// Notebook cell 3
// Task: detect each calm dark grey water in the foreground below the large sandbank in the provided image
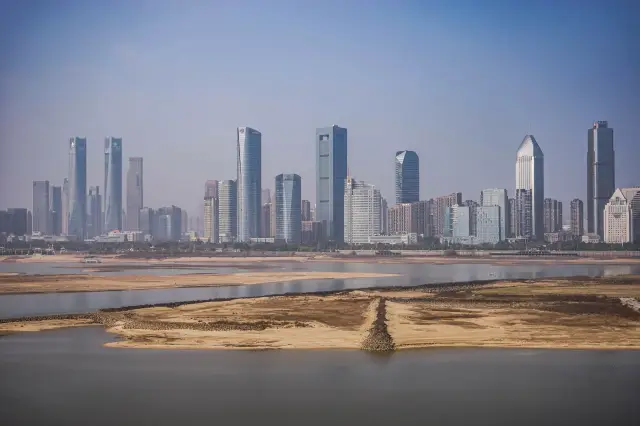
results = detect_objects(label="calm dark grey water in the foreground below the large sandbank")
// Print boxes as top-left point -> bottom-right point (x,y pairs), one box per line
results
0,327 -> 640,426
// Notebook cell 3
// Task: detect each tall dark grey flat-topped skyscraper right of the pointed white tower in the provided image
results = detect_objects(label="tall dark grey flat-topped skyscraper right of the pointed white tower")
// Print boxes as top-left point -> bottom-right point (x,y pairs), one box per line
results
586,121 -> 616,238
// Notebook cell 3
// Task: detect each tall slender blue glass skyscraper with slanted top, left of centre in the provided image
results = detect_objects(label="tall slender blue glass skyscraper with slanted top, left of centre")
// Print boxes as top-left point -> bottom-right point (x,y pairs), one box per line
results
237,127 -> 262,242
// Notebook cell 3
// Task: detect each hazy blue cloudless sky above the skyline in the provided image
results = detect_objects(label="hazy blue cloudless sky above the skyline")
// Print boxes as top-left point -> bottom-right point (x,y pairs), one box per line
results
0,0 -> 640,218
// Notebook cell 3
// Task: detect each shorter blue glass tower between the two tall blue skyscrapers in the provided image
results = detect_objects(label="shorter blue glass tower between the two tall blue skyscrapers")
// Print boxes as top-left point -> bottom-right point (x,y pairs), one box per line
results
275,174 -> 302,244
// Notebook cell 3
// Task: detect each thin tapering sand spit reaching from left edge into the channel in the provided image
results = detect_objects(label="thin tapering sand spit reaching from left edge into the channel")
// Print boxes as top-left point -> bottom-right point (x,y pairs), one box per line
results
0,271 -> 397,294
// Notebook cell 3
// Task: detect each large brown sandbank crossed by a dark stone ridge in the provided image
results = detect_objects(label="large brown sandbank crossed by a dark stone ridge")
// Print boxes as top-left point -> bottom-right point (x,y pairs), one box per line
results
0,276 -> 640,351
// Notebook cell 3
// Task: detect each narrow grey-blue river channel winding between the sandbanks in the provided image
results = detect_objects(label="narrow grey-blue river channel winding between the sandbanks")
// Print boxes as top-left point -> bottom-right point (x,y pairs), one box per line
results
0,262 -> 640,318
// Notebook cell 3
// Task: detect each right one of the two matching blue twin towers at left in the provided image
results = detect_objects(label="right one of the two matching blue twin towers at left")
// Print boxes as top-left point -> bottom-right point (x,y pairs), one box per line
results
103,137 -> 123,232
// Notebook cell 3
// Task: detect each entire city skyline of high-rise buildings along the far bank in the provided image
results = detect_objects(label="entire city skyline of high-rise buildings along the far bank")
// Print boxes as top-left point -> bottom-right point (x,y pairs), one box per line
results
0,121 -> 640,245
